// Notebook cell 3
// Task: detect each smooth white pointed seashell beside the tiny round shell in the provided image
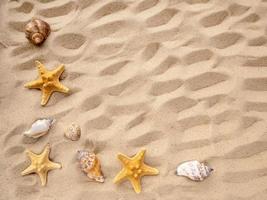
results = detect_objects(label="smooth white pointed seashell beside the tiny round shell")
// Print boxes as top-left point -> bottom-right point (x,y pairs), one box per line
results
23,118 -> 56,138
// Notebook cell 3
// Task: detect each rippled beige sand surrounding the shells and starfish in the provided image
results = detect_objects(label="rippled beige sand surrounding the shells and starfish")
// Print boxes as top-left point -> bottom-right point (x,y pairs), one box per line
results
0,0 -> 267,200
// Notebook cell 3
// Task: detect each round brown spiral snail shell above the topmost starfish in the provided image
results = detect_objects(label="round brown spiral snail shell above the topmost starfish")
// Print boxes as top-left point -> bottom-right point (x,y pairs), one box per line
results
25,19 -> 51,45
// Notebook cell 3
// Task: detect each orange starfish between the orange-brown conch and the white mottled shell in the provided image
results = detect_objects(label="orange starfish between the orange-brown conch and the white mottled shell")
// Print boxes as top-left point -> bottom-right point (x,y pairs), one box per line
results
114,149 -> 159,193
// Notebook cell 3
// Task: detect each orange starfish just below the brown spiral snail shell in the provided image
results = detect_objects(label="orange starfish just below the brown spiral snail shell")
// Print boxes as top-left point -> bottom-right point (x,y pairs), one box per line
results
24,61 -> 69,106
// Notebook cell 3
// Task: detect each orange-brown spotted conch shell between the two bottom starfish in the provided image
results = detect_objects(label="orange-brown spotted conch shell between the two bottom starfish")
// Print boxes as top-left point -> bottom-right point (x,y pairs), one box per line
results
78,150 -> 104,183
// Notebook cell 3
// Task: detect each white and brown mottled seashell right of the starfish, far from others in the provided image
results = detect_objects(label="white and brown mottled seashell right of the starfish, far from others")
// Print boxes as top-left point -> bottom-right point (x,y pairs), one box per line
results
176,160 -> 213,181
